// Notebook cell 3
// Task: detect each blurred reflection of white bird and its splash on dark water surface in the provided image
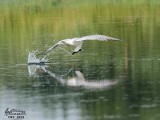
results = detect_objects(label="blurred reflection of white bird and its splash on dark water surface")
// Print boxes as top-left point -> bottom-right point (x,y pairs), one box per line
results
28,64 -> 118,89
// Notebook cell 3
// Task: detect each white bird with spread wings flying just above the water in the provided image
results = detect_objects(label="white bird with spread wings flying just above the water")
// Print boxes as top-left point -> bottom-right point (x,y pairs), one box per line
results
44,35 -> 119,55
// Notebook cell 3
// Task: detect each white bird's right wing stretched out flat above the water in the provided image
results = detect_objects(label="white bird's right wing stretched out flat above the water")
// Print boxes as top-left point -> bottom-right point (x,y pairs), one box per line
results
76,35 -> 119,41
